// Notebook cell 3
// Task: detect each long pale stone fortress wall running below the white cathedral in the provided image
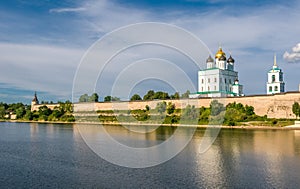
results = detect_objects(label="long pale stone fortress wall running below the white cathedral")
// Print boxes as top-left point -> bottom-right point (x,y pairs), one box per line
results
34,92 -> 300,118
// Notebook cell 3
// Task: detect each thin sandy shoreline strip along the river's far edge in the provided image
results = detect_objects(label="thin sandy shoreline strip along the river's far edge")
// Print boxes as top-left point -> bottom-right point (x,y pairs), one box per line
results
0,120 -> 300,130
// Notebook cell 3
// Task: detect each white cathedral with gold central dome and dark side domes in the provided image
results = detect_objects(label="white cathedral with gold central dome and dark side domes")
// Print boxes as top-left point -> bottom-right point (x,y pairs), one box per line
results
190,47 -> 243,98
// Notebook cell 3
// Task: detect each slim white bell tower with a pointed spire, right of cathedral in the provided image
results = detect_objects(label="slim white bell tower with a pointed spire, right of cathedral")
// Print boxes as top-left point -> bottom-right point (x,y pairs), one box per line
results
267,55 -> 285,94
